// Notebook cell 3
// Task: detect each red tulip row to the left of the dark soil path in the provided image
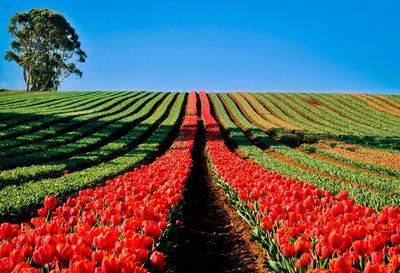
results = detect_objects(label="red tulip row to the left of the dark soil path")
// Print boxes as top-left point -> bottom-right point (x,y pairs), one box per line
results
0,100 -> 198,273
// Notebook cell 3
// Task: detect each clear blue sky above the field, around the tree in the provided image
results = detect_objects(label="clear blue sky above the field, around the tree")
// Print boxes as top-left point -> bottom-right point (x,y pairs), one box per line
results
0,0 -> 400,93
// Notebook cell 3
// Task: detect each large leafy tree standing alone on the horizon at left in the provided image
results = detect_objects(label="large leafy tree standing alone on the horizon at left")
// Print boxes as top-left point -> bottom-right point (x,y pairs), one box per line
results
5,8 -> 87,91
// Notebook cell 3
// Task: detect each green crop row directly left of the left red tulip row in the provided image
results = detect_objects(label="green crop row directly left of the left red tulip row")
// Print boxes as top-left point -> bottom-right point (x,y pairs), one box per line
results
0,94 -> 185,216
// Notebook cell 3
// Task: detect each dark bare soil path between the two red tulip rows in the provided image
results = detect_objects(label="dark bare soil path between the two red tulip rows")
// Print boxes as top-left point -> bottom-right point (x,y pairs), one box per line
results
168,119 -> 266,273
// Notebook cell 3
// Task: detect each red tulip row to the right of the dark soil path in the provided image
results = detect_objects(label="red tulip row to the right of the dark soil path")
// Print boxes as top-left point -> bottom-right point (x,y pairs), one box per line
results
200,93 -> 400,273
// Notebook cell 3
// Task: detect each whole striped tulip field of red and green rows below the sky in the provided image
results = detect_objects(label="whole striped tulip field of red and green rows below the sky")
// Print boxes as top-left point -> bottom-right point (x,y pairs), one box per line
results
0,91 -> 400,273
